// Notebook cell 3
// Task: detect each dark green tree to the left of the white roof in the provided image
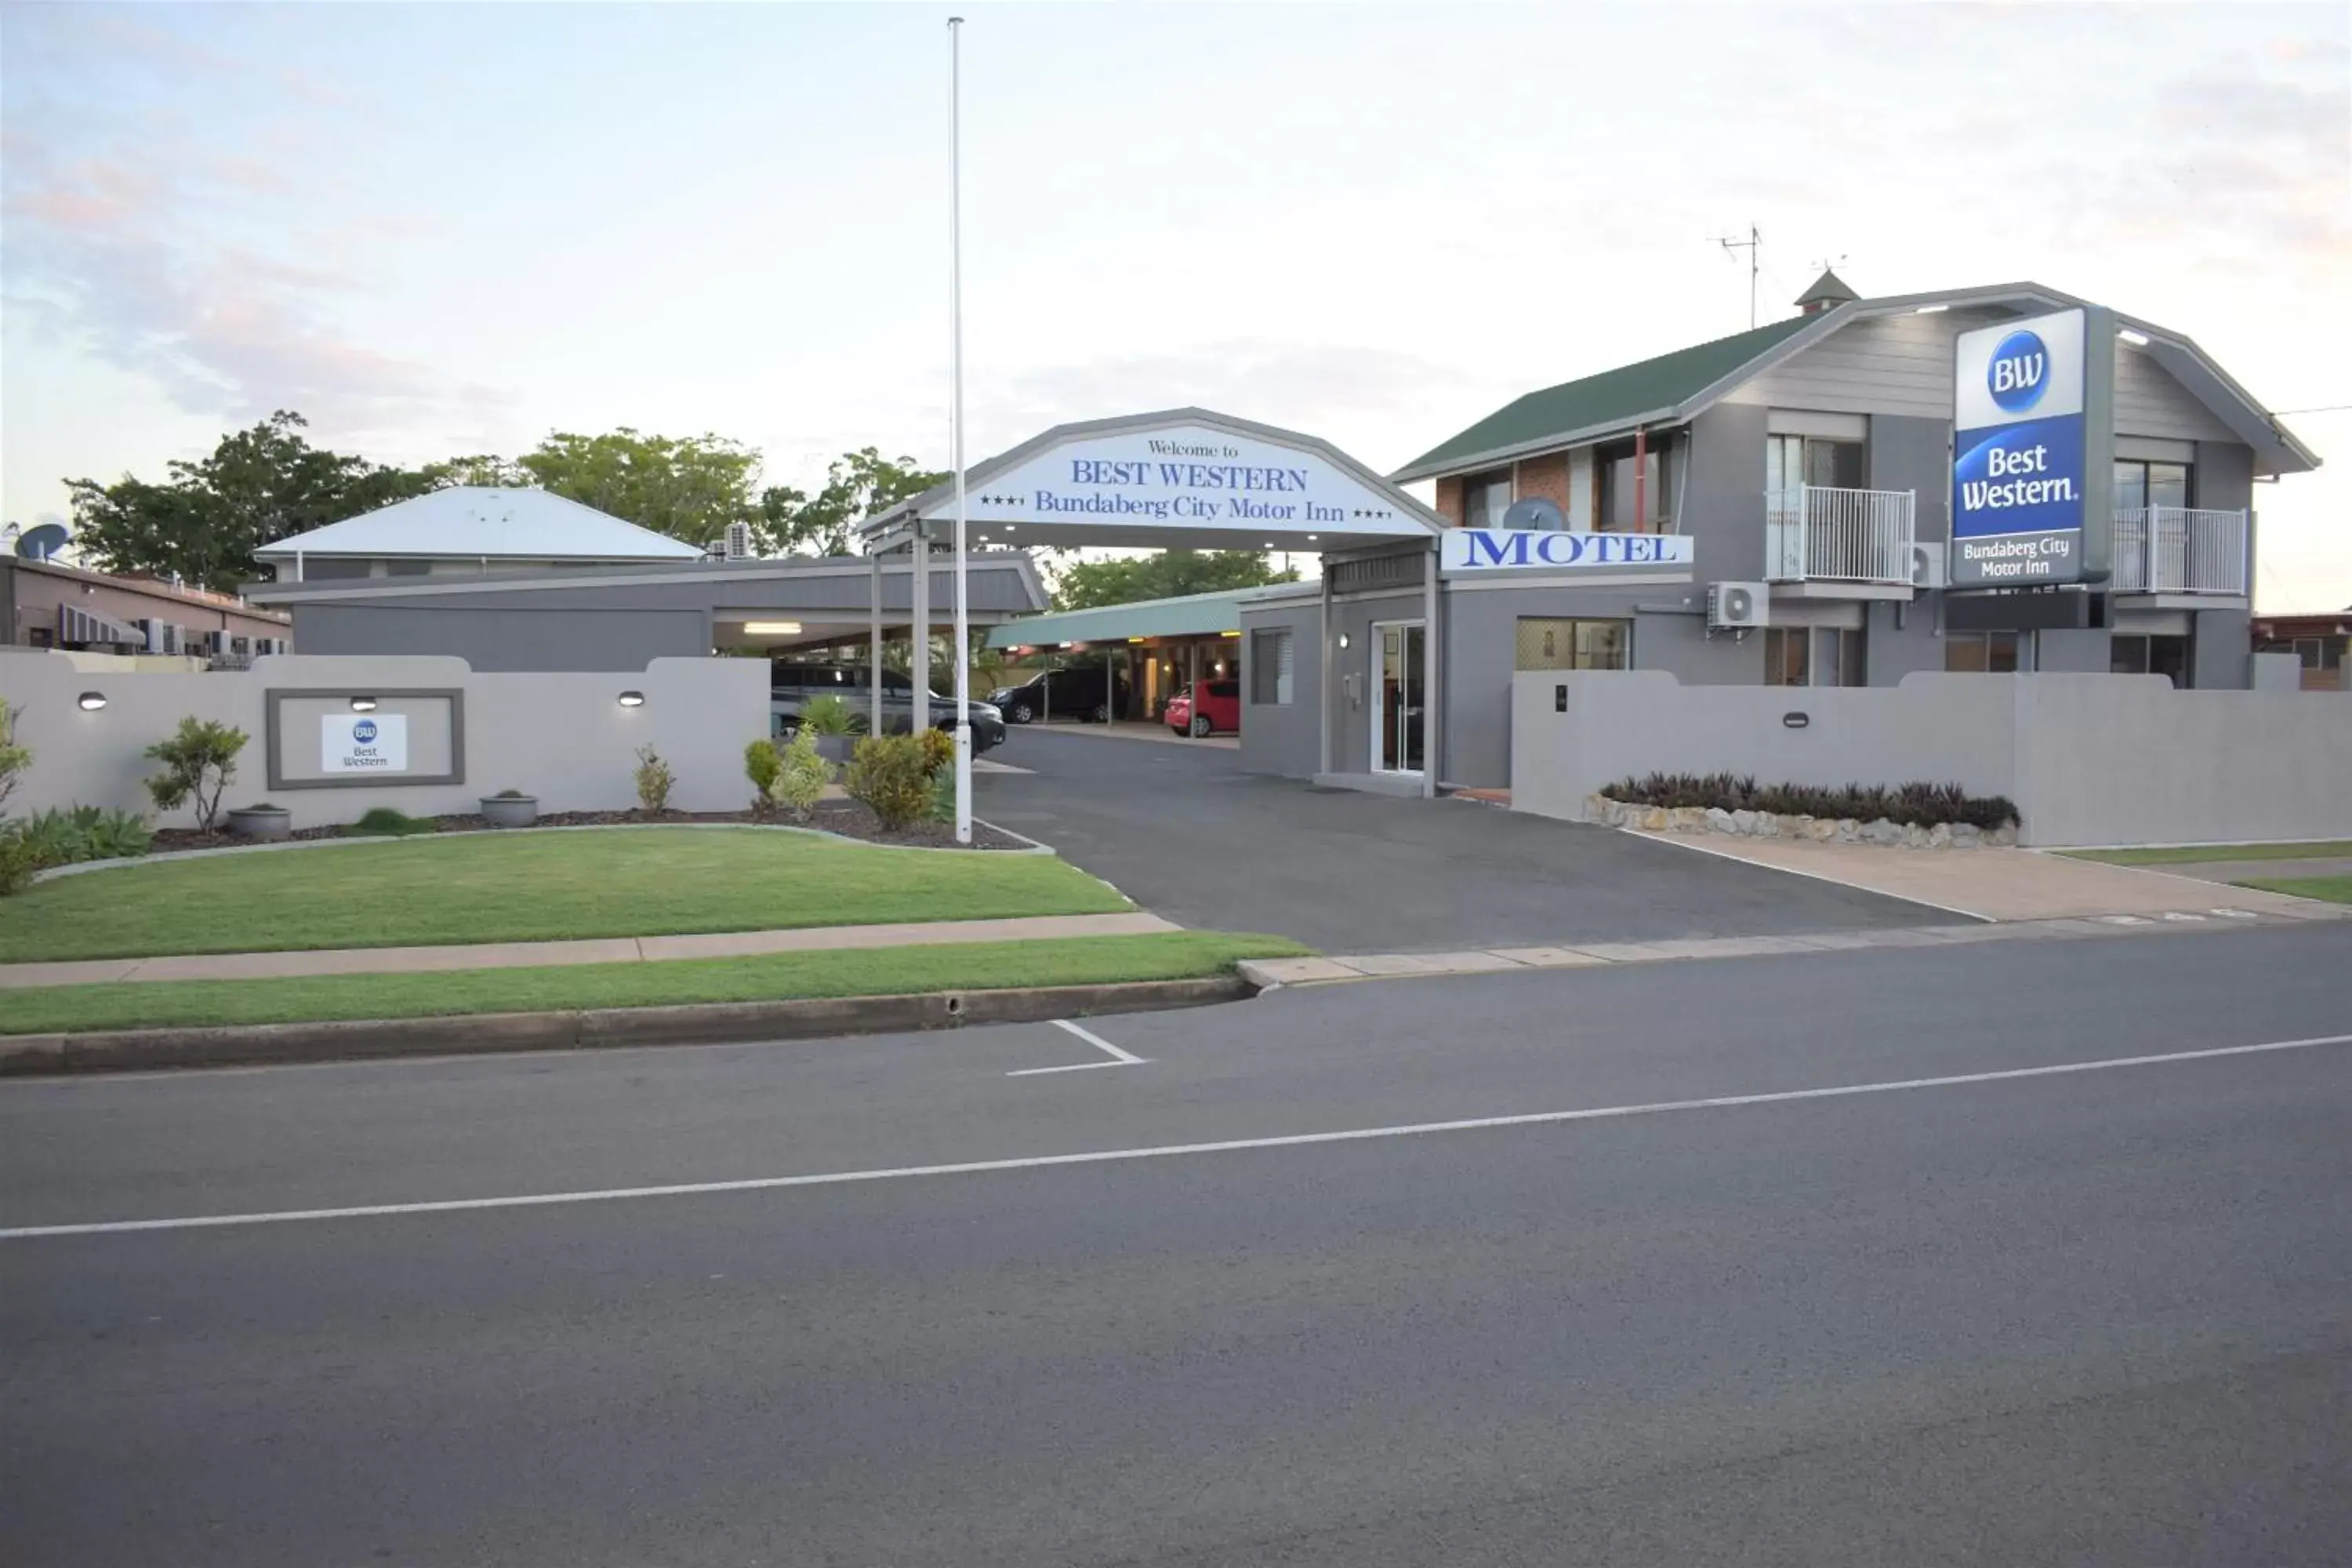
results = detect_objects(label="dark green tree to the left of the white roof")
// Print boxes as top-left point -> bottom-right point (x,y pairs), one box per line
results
66,409 -> 449,593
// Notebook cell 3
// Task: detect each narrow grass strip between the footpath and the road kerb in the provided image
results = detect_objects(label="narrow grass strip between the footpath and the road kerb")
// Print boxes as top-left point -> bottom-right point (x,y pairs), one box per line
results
0,931 -> 1305,1034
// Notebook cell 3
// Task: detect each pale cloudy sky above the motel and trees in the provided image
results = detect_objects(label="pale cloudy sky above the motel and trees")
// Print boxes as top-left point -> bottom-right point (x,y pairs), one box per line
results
0,0 -> 2352,609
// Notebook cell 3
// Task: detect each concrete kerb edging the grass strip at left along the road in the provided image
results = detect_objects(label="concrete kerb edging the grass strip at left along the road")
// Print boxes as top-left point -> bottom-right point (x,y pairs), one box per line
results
0,973 -> 1261,1076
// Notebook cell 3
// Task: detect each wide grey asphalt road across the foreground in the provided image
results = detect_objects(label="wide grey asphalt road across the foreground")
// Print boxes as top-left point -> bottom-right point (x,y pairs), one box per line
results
13,926 -> 2352,1568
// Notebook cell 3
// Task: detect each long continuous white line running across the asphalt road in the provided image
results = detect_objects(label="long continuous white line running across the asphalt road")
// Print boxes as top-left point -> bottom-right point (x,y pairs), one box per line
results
0,1034 -> 2352,1241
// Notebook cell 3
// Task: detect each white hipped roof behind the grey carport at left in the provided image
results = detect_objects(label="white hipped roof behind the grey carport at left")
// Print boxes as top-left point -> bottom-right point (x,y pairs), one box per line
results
254,485 -> 703,562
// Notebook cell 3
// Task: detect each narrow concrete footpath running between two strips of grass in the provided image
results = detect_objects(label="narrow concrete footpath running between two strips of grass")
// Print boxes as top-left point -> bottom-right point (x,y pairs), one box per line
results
0,909 -> 1183,989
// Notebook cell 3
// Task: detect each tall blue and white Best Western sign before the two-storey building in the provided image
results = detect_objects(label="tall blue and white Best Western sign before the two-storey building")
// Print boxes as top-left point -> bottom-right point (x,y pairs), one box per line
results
1950,310 -> 2089,588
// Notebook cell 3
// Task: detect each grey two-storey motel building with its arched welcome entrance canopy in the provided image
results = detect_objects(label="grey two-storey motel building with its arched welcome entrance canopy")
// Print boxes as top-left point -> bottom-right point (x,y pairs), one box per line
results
908,273 -> 2319,794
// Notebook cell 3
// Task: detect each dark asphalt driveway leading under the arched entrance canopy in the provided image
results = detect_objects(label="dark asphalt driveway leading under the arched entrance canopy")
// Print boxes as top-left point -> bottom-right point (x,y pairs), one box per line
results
976,727 -> 1959,952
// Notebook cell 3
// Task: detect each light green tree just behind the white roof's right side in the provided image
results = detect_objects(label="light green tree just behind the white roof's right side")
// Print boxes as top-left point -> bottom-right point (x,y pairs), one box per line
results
517,426 -> 760,546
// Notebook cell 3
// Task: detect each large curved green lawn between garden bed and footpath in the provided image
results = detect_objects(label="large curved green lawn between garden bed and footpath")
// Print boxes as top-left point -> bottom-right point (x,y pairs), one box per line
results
0,827 -> 1131,961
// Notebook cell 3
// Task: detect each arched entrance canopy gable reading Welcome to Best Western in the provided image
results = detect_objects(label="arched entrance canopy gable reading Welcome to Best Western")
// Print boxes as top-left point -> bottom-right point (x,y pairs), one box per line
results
866,409 -> 1444,555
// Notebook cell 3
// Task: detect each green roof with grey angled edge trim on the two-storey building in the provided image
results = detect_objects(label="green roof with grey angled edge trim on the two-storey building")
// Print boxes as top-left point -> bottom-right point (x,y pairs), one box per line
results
1390,278 -> 2319,485
